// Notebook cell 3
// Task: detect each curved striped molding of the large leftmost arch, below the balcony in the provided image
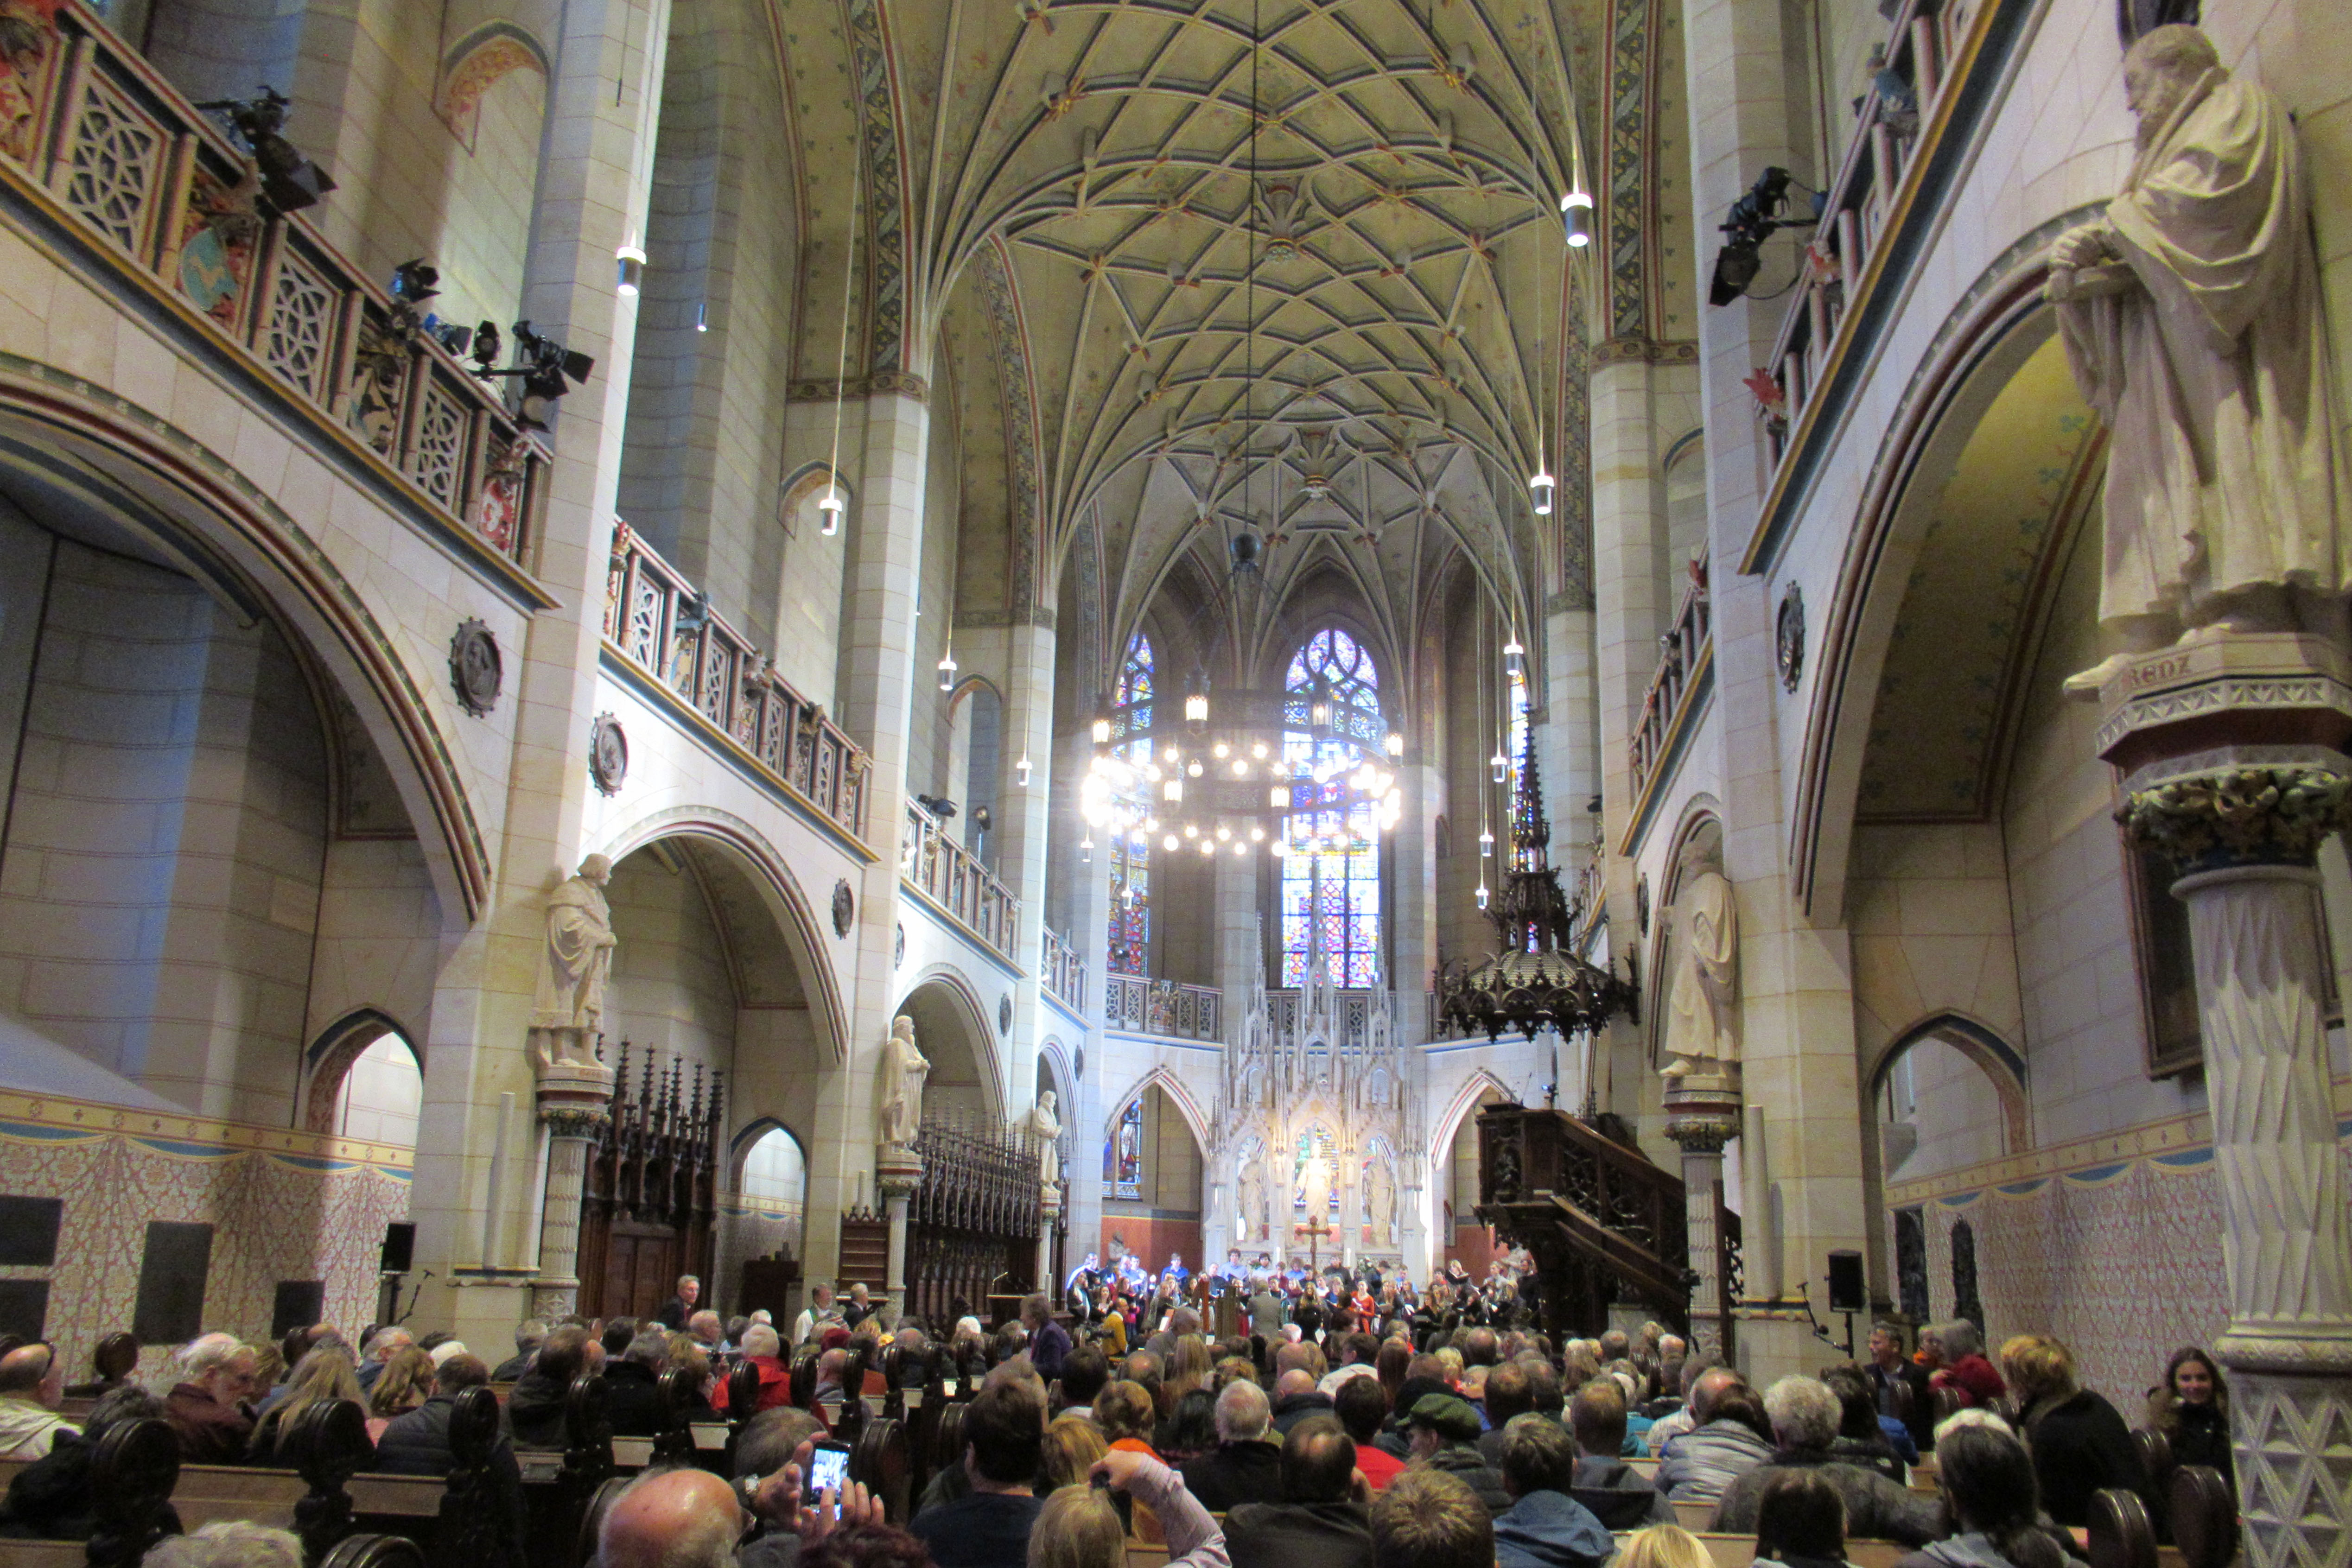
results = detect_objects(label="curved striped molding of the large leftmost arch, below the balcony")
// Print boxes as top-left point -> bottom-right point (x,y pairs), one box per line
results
0,371 -> 491,926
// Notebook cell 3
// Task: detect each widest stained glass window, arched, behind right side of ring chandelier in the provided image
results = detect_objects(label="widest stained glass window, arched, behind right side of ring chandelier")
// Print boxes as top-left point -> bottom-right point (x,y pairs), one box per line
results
1282,625 -> 1388,987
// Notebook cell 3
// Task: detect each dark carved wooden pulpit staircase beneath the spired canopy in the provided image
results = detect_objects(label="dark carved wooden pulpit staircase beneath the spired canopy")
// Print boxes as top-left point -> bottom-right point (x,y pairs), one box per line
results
1477,1105 -> 1691,1338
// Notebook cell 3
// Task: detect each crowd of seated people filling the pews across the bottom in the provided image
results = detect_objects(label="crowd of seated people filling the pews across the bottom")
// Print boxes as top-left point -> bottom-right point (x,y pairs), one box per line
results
0,1288 -> 2230,1568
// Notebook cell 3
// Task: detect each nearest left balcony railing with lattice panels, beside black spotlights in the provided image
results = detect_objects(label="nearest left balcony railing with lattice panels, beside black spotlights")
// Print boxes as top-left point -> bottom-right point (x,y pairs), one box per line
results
0,0 -> 550,576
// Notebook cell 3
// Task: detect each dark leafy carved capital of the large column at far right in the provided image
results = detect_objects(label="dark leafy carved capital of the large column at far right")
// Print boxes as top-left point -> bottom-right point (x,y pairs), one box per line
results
2117,759 -> 2352,877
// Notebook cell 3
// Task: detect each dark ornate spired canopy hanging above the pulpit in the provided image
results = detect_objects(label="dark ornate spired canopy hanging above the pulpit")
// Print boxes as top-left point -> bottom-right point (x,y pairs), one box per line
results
1437,736 -> 1640,1041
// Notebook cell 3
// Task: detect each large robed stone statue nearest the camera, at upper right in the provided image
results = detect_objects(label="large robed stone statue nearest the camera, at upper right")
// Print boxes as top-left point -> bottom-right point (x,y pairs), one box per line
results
2046,26 -> 2352,693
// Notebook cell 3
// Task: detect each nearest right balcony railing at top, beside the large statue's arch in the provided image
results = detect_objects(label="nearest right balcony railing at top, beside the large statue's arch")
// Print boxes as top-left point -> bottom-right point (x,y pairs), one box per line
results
1743,0 -> 2034,571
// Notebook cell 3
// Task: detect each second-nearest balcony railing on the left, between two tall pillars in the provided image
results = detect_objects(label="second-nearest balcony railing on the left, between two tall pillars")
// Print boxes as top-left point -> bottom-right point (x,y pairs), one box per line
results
604,522 -> 870,842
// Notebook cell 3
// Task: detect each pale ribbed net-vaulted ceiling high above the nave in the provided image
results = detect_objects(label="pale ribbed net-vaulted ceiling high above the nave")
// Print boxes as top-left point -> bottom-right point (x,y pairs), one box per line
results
783,0 -> 1646,681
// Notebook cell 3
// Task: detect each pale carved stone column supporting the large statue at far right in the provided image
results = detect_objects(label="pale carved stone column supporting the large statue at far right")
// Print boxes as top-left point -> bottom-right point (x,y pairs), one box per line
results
2100,635 -> 2352,1568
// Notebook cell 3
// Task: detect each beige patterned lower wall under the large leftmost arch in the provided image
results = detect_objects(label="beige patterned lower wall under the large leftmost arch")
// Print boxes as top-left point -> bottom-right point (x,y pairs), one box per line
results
0,1093 -> 412,1380
